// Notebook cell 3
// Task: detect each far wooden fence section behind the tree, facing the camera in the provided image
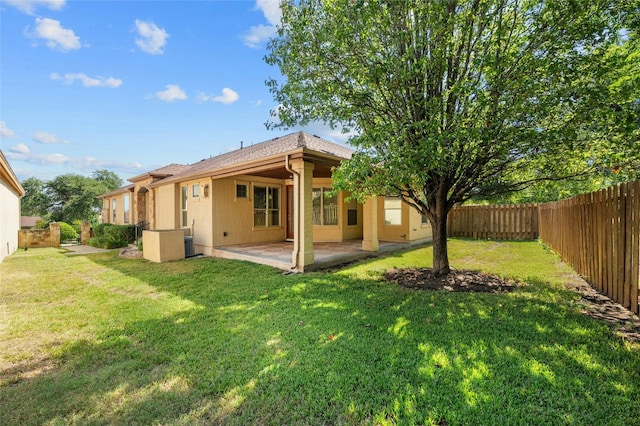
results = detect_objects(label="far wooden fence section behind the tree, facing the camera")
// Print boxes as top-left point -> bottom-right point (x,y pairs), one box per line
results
447,204 -> 538,240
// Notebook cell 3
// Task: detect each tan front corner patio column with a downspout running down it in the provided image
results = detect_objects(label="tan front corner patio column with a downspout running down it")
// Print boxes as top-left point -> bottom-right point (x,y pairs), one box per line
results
291,161 -> 314,271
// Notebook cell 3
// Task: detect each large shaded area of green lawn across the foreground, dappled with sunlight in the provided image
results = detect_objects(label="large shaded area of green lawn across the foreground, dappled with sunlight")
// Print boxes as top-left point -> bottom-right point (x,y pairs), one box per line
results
0,250 -> 640,425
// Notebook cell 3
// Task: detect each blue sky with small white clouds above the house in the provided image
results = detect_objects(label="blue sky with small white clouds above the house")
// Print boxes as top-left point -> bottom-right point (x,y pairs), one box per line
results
0,0 -> 345,180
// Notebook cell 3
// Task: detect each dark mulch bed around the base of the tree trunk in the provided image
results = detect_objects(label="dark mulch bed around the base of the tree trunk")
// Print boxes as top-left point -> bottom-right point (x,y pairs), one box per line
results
384,268 -> 522,293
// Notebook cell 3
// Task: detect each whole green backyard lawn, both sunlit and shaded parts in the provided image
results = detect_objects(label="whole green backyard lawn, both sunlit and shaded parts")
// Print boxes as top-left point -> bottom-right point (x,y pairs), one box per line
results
0,240 -> 640,425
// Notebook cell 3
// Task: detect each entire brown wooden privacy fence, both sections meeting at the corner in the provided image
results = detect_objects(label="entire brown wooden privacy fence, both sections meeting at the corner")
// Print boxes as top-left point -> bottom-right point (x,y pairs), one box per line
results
448,180 -> 640,314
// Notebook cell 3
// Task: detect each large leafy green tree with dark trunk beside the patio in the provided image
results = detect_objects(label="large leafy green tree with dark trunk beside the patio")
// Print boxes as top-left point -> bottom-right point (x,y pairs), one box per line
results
266,0 -> 638,274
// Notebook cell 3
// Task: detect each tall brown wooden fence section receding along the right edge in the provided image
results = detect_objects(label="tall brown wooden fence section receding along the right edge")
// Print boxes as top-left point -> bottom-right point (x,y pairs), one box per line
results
539,180 -> 640,314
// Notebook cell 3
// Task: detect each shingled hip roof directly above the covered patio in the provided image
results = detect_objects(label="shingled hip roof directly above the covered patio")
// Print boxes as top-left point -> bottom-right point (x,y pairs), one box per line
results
158,132 -> 354,184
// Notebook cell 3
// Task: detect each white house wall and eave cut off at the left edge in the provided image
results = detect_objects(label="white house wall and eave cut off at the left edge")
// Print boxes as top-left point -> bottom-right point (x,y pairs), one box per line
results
0,151 -> 24,262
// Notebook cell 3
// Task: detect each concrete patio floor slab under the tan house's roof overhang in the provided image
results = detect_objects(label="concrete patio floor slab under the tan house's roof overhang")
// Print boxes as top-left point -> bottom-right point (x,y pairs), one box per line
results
213,238 -> 431,271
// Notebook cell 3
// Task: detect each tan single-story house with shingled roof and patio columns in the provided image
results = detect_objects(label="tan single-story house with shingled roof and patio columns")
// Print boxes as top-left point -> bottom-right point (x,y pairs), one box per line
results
100,132 -> 431,269
